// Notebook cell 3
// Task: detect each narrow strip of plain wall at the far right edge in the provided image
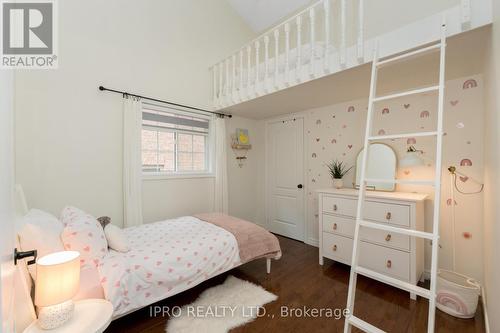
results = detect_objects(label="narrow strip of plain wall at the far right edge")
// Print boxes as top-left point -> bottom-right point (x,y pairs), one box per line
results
484,1 -> 500,332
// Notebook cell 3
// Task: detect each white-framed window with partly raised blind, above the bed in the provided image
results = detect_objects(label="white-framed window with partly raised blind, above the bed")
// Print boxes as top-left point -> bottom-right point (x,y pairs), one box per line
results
142,104 -> 212,175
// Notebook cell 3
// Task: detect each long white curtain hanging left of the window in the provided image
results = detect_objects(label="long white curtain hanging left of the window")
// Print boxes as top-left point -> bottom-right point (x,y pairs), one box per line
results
123,96 -> 142,227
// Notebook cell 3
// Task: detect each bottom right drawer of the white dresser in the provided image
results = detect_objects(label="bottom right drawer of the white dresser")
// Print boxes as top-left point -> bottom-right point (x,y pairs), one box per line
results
359,241 -> 410,281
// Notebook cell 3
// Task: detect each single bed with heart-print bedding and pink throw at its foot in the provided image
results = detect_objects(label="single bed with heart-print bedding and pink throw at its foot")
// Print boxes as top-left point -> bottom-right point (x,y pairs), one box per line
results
14,187 -> 281,318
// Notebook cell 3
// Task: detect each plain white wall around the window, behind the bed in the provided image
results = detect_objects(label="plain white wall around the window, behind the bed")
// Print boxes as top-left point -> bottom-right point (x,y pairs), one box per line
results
15,0 -> 253,225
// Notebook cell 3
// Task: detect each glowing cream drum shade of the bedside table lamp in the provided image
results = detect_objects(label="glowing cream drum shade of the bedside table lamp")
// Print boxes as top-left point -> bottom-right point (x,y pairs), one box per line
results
35,251 -> 80,306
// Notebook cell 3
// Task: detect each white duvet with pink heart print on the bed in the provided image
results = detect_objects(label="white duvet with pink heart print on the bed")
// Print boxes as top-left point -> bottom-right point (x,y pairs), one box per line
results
98,216 -> 281,317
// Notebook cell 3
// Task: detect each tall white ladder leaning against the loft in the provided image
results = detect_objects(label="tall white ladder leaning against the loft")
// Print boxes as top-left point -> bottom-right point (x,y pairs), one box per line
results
344,20 -> 446,333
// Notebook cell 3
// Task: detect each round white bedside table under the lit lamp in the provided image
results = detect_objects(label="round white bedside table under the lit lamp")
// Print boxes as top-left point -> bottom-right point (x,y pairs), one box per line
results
24,299 -> 113,333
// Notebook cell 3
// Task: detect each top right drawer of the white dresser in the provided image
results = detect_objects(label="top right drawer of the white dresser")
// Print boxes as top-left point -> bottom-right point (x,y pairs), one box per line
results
364,201 -> 410,227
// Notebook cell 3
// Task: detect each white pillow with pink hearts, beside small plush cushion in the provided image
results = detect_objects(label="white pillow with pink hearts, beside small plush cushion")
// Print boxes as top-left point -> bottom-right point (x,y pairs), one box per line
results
61,207 -> 108,266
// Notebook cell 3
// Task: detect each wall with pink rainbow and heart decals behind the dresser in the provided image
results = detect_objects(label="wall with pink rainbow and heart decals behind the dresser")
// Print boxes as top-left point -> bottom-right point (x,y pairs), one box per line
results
305,75 -> 484,281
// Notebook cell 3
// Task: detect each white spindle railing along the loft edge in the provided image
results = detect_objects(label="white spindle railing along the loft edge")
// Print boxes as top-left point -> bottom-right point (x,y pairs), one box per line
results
210,0 -> 364,108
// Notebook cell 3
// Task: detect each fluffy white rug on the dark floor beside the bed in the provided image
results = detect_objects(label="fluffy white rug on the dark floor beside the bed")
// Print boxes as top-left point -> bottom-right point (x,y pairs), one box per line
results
166,276 -> 278,333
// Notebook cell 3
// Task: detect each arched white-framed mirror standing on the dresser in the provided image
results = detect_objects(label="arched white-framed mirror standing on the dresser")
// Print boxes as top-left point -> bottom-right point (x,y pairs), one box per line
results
355,143 -> 397,191
